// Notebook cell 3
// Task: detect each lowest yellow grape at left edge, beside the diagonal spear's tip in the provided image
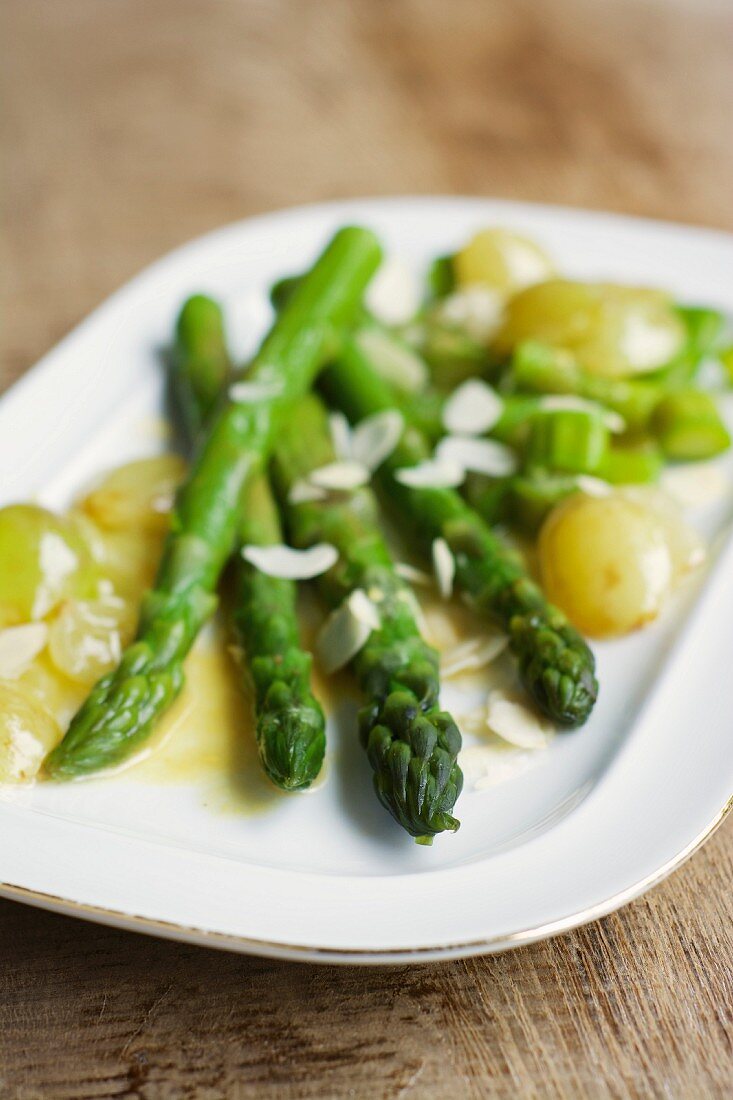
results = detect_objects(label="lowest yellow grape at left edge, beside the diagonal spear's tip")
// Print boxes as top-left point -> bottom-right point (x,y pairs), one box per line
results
0,681 -> 61,783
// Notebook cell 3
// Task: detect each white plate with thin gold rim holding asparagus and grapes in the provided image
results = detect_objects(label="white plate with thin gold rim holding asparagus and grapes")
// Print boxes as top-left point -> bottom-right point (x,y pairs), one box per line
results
0,198 -> 733,963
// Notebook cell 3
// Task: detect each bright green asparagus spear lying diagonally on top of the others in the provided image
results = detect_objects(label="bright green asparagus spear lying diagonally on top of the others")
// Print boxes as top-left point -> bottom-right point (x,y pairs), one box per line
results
46,228 -> 381,779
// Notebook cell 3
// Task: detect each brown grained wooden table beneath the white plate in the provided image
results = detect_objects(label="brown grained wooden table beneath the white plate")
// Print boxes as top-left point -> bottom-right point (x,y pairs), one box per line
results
0,0 -> 733,1100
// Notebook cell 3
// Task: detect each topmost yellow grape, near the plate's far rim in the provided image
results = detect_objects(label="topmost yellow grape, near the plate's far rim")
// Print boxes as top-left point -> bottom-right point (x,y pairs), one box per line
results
453,229 -> 555,294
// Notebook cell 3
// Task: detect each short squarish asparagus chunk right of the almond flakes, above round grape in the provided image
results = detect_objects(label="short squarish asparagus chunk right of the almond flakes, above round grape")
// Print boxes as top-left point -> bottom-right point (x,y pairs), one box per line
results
525,409 -> 609,474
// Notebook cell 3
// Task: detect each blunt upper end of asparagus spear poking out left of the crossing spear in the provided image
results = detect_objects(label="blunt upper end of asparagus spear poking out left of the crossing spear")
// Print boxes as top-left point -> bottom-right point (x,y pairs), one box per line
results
171,294 -> 231,441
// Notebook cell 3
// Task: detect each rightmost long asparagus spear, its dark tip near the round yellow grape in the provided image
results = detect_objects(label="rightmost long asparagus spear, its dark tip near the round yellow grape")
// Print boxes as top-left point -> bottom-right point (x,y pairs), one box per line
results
321,340 -> 598,726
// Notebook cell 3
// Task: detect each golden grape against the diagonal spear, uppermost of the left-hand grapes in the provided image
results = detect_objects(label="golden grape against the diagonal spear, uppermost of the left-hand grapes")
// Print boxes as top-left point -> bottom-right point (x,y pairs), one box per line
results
80,454 -> 186,531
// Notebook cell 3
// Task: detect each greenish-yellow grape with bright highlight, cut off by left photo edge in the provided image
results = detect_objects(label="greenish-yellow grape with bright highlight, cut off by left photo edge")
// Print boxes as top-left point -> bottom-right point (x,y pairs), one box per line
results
0,504 -> 97,627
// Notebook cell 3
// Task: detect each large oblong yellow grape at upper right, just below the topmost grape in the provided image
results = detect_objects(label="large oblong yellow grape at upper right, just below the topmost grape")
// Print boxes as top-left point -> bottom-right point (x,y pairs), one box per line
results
496,278 -> 685,378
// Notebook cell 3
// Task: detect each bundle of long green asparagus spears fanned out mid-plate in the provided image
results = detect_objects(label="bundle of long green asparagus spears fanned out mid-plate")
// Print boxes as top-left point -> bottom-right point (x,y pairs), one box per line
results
46,221 -> 620,843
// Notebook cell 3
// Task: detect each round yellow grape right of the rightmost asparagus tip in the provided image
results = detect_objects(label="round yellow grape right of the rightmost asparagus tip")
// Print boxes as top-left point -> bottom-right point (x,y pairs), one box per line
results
539,493 -> 674,638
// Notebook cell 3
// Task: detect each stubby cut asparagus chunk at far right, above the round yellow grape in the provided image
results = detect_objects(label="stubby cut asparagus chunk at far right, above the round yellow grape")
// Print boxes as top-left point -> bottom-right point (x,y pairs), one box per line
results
652,389 -> 731,461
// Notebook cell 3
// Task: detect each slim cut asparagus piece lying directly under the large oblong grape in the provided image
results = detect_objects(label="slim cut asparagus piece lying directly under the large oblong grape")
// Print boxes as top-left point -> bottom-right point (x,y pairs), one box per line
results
508,341 -> 664,431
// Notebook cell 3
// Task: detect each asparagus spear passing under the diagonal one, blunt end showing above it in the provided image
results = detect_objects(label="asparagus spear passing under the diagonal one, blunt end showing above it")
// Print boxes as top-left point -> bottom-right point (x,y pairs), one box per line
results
171,295 -> 326,791
